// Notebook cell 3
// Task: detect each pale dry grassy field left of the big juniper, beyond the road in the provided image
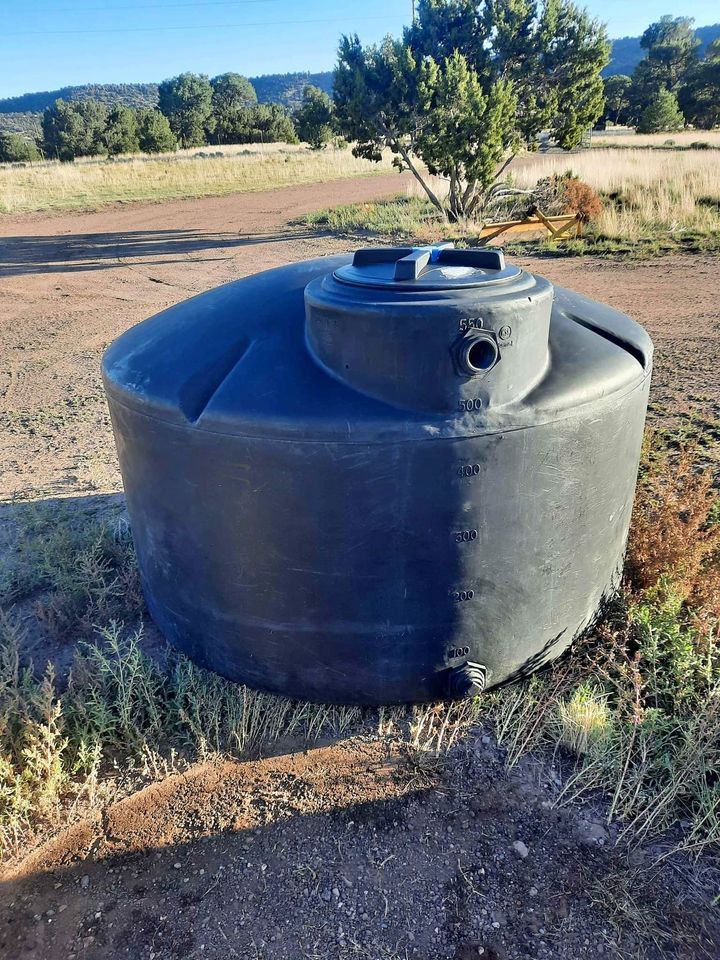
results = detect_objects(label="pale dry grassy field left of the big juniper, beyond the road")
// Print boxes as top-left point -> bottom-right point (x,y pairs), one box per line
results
0,144 -> 390,214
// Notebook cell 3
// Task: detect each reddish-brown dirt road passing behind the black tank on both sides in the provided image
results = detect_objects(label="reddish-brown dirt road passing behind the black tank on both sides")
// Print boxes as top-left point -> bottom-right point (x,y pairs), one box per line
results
0,175 -> 720,499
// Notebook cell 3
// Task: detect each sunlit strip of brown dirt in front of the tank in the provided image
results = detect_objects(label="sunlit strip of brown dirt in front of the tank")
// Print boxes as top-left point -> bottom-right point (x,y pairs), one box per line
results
5,741 -> 401,881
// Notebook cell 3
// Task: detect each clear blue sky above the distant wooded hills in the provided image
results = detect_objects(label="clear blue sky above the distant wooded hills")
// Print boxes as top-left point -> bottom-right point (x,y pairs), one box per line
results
0,0 -> 720,97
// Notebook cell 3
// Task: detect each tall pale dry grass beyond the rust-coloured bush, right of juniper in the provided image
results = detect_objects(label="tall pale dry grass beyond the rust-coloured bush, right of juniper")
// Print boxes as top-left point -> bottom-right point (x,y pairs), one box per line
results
511,148 -> 720,241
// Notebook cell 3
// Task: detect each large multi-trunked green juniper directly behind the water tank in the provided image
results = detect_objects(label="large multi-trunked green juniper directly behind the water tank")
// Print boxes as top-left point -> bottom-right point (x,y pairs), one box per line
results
334,0 -> 609,220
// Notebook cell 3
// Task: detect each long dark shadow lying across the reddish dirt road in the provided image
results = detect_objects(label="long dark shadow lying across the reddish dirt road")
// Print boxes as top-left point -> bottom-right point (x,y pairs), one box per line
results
0,230 -> 316,277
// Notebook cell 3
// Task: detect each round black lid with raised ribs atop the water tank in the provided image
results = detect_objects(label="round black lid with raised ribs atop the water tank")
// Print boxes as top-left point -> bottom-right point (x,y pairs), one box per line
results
333,243 -> 522,290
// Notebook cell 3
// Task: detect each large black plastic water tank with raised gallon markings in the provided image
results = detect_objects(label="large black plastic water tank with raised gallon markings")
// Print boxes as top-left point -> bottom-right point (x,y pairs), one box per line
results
103,247 -> 652,703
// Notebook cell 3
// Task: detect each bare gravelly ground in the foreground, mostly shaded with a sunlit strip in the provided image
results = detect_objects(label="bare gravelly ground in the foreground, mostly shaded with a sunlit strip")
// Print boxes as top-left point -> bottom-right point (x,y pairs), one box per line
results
0,733 -> 720,960
